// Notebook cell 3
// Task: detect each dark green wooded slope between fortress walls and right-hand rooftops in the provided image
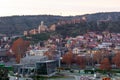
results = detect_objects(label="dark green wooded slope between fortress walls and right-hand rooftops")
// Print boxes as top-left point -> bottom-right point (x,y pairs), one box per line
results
56,21 -> 120,37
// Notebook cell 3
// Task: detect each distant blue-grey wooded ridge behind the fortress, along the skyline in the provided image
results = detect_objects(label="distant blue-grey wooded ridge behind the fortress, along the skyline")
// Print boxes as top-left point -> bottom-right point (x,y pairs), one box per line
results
0,12 -> 120,35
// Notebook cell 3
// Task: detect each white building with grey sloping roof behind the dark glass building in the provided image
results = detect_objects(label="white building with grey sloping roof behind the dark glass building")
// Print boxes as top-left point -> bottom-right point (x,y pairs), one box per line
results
20,48 -> 48,66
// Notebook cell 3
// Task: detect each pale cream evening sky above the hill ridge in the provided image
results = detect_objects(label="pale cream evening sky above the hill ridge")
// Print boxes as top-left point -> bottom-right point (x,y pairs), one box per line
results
0,0 -> 120,16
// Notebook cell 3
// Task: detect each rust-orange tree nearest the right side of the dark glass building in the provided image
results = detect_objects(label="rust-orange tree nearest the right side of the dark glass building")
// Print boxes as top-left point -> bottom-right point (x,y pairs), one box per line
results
62,51 -> 73,68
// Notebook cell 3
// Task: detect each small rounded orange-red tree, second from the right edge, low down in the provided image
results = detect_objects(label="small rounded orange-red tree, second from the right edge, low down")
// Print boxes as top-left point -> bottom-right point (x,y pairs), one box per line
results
100,58 -> 111,70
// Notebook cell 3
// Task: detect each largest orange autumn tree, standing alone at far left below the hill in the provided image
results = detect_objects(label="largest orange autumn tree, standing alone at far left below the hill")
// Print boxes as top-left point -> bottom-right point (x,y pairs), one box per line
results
12,38 -> 30,63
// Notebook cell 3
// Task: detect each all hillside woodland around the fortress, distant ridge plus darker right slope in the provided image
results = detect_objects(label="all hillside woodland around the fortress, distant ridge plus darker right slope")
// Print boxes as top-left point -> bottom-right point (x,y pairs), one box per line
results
0,12 -> 120,36
